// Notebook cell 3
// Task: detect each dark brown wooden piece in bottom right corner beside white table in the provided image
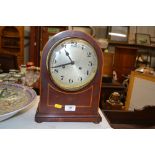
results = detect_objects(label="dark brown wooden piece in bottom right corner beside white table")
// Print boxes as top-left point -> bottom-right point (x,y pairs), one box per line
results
103,106 -> 155,129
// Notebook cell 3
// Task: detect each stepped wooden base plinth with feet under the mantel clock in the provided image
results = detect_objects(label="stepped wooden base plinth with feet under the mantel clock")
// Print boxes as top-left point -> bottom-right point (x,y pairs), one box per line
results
35,109 -> 102,124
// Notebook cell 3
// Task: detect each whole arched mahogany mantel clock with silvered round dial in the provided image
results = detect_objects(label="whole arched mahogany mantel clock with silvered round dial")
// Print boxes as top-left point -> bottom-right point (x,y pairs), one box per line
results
35,31 -> 103,123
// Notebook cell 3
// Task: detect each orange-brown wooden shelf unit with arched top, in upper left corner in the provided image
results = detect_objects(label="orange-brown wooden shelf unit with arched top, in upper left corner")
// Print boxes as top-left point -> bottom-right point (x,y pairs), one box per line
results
0,26 -> 24,66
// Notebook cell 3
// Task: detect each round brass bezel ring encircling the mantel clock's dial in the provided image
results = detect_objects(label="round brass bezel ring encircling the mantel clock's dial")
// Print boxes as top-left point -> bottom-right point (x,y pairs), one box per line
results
46,37 -> 98,91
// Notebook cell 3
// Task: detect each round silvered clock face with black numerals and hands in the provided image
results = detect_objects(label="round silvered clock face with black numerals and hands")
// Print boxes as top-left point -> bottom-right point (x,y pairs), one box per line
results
47,38 -> 98,91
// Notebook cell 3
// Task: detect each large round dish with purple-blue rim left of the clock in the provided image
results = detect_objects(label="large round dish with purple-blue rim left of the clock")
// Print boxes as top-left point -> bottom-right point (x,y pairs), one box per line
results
0,83 -> 37,121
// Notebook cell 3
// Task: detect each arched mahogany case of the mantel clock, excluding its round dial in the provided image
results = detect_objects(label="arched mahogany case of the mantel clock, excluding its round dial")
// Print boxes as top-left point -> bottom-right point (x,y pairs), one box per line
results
35,31 -> 103,123
